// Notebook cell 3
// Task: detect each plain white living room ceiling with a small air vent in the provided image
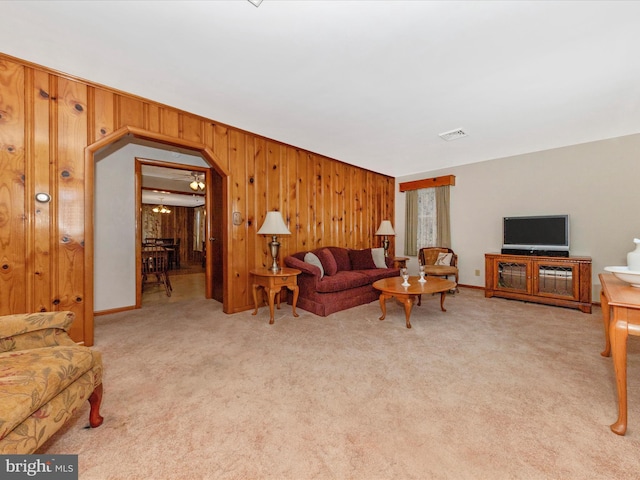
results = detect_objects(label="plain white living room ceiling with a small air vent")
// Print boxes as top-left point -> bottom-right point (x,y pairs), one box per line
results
0,0 -> 640,176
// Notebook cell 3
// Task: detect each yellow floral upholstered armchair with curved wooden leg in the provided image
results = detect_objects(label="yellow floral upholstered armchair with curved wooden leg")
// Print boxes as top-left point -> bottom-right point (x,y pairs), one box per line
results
0,312 -> 102,454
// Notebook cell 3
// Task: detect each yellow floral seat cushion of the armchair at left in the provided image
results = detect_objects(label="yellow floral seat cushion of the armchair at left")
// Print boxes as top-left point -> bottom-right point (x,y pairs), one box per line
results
0,346 -> 100,439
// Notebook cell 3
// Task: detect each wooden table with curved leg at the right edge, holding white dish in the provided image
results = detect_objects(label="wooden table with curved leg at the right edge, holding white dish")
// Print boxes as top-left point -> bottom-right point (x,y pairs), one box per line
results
598,273 -> 640,435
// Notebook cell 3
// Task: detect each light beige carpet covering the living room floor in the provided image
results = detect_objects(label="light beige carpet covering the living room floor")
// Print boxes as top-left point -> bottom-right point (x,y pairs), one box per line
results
40,289 -> 640,480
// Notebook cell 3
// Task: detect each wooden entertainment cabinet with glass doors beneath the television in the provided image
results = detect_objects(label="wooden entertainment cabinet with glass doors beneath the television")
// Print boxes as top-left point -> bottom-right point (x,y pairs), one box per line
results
484,253 -> 591,313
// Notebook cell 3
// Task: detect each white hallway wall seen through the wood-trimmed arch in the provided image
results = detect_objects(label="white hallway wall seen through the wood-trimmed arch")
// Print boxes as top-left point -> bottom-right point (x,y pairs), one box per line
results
93,138 -> 208,312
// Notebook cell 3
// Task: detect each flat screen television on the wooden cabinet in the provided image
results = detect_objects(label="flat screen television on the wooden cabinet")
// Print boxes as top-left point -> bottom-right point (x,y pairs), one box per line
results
502,215 -> 569,252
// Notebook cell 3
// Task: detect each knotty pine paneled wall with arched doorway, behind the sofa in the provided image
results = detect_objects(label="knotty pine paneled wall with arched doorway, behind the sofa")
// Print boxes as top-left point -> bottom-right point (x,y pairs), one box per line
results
0,54 -> 395,345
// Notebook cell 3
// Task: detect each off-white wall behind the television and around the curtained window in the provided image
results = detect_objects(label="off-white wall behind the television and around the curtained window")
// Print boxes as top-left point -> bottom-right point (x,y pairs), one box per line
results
394,134 -> 640,301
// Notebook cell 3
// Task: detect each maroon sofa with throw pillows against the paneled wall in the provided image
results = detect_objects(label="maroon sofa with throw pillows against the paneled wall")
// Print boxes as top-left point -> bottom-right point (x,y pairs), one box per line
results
284,247 -> 400,317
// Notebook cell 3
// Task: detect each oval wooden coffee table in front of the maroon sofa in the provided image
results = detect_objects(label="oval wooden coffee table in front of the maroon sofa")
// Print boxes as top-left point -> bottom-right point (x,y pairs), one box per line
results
373,277 -> 456,328
